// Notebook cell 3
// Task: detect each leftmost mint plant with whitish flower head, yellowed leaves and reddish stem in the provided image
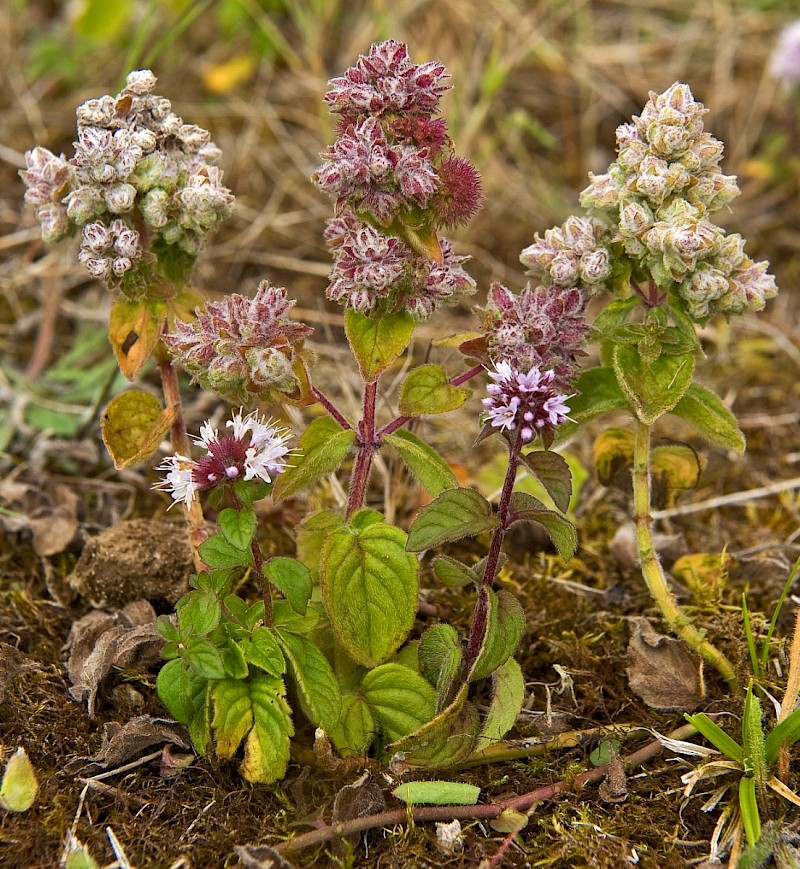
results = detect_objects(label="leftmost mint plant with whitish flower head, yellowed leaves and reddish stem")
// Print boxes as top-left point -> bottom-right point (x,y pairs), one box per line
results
20,69 -> 233,548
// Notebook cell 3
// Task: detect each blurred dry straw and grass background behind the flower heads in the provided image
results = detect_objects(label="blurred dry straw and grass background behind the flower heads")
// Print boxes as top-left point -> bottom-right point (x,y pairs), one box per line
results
0,0 -> 800,450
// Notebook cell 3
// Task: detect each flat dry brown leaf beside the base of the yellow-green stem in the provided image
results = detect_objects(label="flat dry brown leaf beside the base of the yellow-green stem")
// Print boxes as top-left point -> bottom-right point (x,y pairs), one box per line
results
628,619 -> 705,712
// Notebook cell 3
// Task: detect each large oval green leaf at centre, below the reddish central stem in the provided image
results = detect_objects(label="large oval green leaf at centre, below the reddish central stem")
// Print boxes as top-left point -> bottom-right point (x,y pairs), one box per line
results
320,522 -> 419,667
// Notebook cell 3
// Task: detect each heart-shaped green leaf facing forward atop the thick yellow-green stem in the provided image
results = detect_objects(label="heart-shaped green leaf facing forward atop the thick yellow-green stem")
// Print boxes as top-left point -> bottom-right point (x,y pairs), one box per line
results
613,344 -> 694,425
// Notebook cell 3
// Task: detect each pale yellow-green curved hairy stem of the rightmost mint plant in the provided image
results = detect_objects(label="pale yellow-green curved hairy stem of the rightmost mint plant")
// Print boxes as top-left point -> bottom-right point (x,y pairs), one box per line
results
633,420 -> 739,694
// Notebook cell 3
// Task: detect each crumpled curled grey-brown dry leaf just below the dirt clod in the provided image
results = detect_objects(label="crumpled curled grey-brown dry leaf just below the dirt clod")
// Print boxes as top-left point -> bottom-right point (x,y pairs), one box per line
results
66,601 -> 164,716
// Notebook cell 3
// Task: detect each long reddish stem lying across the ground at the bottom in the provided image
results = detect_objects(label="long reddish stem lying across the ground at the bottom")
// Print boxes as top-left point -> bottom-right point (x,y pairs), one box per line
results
274,724 -> 697,855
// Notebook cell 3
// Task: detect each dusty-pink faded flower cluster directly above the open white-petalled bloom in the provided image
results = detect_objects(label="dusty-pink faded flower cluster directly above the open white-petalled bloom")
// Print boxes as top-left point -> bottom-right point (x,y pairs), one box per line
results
164,281 -> 314,405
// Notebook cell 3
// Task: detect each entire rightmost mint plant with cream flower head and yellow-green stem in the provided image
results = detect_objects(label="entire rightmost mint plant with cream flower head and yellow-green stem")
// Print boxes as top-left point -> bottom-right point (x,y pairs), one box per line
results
536,83 -> 777,687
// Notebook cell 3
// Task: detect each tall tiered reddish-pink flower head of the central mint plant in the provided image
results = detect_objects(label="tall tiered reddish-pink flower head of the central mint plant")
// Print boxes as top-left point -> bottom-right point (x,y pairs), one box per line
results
313,40 -> 483,320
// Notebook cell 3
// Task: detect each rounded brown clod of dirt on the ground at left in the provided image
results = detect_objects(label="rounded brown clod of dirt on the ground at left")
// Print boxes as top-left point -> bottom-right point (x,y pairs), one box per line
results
68,519 -> 194,607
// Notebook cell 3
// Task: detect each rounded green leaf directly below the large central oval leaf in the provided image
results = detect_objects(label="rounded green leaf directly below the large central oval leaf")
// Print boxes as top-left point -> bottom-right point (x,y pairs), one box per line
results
362,664 -> 436,742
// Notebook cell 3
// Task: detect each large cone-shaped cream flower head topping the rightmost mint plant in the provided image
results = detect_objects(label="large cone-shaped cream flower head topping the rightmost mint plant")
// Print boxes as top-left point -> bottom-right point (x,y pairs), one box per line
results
576,82 -> 777,322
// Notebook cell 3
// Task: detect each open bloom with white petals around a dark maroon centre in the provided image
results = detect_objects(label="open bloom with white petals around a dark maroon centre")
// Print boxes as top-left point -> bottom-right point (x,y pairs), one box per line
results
155,411 -> 291,507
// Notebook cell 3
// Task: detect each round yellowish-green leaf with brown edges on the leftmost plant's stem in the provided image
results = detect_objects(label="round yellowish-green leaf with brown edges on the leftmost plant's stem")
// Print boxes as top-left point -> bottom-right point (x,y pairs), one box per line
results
102,389 -> 175,471
